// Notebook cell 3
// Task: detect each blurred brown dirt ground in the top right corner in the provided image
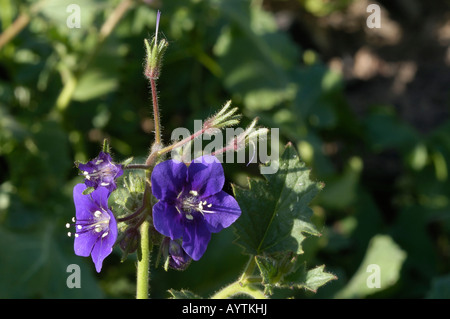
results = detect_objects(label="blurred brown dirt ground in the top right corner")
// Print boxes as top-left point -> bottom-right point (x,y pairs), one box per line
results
265,0 -> 450,134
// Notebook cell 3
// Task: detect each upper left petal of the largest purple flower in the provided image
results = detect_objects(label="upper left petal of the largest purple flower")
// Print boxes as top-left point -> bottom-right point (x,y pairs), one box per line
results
151,160 -> 187,200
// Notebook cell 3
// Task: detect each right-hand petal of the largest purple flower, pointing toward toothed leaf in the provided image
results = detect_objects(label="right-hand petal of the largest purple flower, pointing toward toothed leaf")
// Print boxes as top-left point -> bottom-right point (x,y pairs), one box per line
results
204,191 -> 241,233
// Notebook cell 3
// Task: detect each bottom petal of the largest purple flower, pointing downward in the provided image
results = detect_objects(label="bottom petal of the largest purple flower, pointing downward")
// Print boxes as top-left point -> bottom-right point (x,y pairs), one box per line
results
183,217 -> 211,260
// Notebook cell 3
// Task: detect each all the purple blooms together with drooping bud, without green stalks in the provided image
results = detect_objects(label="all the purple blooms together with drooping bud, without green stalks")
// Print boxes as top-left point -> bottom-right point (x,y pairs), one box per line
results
67,152 -> 241,272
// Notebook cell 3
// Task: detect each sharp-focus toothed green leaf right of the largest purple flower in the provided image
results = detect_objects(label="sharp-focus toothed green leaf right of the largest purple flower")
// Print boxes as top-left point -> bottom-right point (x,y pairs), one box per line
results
233,144 -> 322,255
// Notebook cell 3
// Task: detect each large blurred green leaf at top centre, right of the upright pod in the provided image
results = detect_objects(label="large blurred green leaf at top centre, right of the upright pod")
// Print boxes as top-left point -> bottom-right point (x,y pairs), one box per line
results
214,0 -> 298,111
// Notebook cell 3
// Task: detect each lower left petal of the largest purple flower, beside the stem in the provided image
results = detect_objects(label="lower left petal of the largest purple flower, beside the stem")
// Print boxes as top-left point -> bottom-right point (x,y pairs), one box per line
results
153,201 -> 184,240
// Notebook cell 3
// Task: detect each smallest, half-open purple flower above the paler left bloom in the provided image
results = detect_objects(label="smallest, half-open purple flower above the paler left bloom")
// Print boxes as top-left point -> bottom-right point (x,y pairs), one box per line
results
78,152 -> 123,193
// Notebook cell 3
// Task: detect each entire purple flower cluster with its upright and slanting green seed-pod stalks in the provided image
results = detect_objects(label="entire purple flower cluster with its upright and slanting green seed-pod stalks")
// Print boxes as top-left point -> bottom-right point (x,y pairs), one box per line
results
67,11 -> 244,272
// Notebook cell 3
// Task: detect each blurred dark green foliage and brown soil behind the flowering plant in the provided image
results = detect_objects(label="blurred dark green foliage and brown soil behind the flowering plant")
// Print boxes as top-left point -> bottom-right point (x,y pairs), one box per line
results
0,0 -> 450,298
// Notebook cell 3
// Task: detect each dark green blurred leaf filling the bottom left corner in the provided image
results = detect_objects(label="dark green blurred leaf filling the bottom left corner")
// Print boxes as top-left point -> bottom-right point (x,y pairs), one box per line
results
0,222 -> 104,298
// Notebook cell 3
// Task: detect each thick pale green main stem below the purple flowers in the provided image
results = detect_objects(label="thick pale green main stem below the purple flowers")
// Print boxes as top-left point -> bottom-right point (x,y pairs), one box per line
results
136,220 -> 153,299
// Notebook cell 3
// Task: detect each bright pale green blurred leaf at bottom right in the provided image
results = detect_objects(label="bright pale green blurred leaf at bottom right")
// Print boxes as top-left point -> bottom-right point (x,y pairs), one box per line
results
336,235 -> 406,298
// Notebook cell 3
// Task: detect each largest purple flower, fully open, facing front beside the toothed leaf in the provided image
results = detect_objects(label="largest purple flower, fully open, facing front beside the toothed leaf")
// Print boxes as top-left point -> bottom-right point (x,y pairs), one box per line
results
151,156 -> 241,260
